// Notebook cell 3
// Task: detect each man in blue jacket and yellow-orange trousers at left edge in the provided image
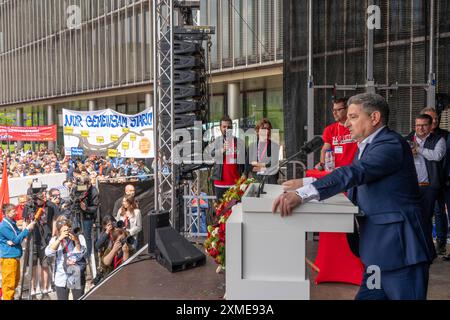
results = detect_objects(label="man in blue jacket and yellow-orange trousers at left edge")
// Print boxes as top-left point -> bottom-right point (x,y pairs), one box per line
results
0,204 -> 36,300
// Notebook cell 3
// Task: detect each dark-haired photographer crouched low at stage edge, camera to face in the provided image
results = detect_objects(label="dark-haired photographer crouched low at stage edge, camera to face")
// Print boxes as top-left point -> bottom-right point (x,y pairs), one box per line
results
102,228 -> 134,276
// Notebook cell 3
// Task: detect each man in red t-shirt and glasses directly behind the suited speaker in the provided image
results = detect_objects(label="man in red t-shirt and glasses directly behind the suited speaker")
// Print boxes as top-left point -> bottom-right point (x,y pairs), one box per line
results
316,98 -> 358,170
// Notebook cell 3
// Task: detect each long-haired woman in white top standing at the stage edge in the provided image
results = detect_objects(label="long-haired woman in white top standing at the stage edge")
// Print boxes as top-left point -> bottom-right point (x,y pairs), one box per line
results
116,196 -> 142,249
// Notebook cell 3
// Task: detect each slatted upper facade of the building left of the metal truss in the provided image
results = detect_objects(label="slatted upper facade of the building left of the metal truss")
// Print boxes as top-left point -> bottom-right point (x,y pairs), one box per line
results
0,0 -> 152,105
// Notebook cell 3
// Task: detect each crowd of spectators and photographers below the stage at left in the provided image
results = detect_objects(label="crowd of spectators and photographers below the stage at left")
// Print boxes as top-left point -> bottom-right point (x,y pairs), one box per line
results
0,149 -> 150,300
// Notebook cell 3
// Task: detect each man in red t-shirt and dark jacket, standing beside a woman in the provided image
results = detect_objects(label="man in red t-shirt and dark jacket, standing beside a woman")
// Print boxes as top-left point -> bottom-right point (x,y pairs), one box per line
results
211,116 -> 245,201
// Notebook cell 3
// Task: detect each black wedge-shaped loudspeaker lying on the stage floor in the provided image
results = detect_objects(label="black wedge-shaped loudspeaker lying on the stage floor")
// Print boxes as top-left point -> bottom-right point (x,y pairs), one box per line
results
155,227 -> 206,272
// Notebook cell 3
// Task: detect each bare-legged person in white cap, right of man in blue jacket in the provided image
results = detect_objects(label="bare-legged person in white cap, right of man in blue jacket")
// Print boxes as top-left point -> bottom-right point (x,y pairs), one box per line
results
23,186 -> 56,295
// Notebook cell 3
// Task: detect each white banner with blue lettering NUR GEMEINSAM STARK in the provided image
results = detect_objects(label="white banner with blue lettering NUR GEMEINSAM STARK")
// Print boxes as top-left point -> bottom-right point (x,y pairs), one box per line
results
63,109 -> 155,158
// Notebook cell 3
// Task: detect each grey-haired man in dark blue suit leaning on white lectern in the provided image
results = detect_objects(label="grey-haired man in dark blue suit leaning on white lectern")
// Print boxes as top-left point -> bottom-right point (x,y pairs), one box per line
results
273,93 -> 435,300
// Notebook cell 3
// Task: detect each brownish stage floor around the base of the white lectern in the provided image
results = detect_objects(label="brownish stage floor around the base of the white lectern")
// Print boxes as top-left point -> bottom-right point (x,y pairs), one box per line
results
86,242 -> 450,300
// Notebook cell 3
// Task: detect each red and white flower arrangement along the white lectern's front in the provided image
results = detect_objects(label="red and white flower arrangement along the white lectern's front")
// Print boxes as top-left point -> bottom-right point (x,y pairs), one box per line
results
204,177 -> 255,273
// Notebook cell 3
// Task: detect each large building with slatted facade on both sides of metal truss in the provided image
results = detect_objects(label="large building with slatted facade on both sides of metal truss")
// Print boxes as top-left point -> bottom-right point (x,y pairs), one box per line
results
0,0 -> 283,149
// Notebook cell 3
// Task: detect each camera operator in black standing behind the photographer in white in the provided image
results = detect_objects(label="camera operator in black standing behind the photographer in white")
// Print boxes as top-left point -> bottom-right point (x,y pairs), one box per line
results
70,176 -> 99,256
